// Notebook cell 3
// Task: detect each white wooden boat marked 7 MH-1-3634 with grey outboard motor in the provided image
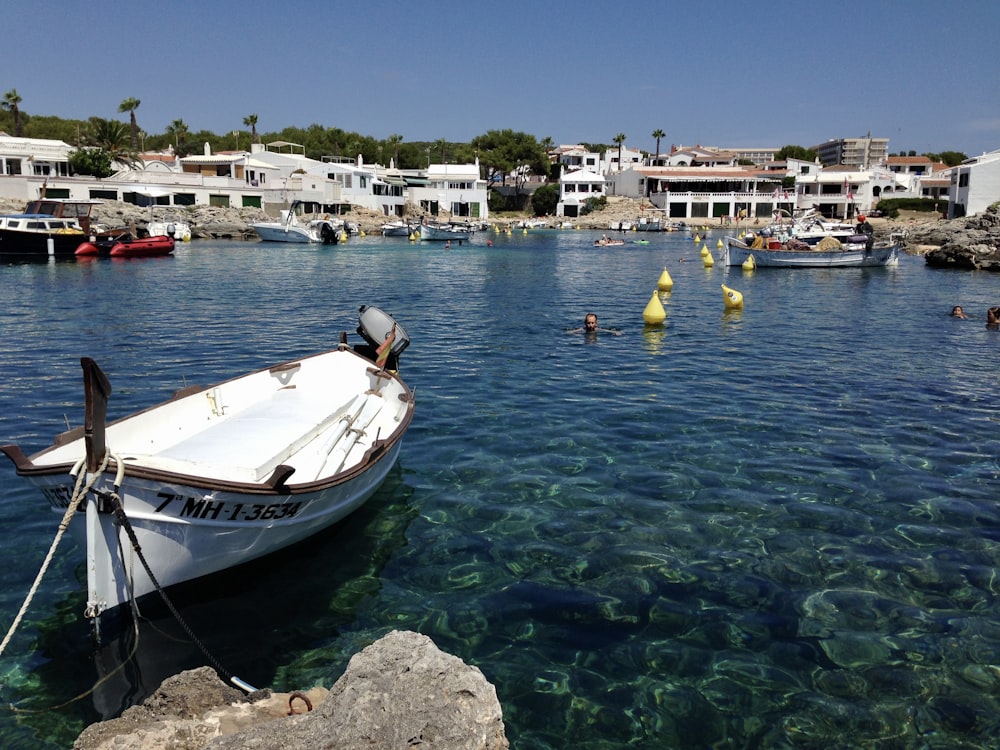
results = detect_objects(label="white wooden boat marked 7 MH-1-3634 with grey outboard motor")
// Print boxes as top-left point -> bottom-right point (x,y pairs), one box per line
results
0,306 -> 414,618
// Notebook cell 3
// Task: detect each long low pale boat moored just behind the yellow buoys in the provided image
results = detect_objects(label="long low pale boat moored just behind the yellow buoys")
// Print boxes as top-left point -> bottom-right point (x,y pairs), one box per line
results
722,234 -> 899,268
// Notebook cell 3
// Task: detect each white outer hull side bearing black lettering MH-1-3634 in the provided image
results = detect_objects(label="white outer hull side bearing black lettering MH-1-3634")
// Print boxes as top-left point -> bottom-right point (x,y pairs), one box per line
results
24,442 -> 402,616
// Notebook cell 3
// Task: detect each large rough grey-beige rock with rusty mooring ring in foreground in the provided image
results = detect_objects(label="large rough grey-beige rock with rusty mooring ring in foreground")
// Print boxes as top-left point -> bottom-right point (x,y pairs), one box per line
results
73,631 -> 509,750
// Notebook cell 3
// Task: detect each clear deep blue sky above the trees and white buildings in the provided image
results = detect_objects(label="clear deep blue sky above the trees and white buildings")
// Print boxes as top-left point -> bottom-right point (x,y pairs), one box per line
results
0,0 -> 1000,156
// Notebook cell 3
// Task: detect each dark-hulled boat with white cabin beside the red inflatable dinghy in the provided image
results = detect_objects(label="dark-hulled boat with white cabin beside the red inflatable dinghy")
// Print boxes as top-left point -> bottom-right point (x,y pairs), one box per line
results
0,198 -> 100,259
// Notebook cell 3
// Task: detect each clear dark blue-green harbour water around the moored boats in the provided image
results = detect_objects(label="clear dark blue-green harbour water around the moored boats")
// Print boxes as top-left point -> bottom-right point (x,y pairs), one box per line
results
0,231 -> 1000,749
